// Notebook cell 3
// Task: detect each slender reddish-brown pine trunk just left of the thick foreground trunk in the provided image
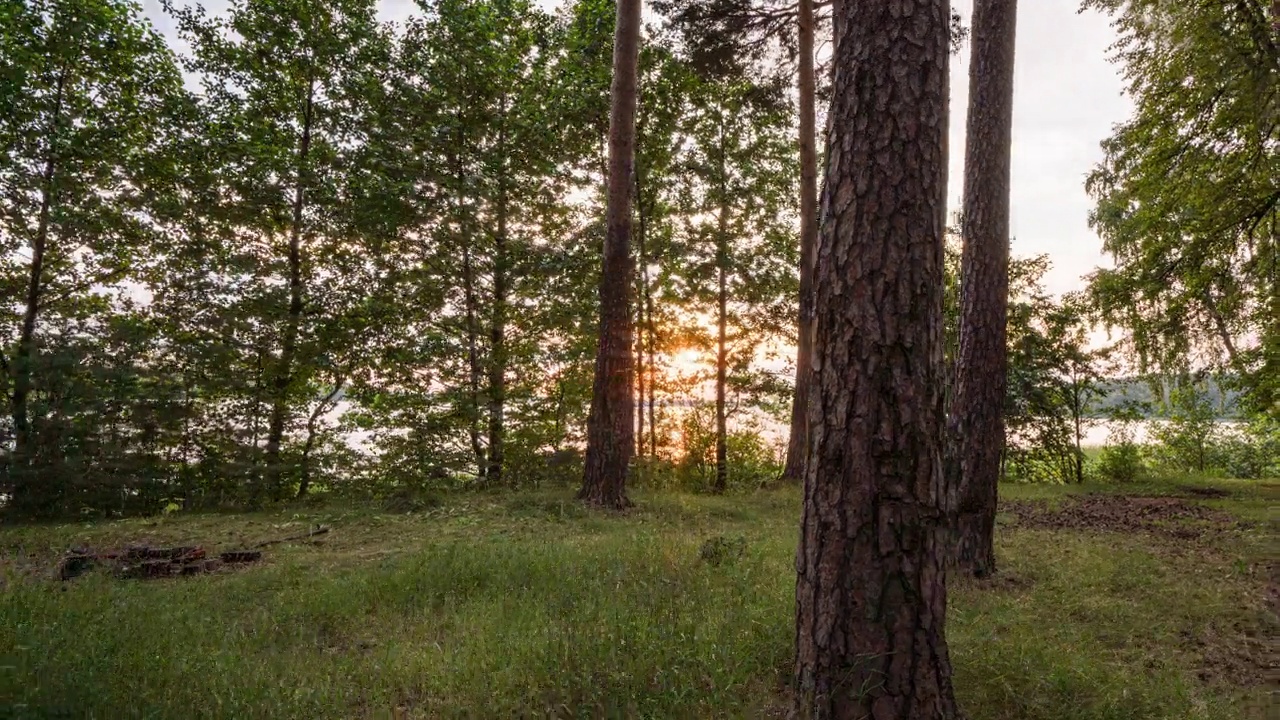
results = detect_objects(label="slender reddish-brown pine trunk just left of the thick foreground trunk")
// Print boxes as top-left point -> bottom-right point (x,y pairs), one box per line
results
782,0 -> 818,483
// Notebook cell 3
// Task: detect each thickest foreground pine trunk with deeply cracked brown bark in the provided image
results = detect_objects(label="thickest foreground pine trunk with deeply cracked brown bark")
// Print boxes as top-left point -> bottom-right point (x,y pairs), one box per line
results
795,0 -> 960,720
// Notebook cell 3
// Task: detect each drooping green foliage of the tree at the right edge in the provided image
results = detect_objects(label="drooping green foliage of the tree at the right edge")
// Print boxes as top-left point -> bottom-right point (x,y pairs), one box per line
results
1084,0 -> 1280,414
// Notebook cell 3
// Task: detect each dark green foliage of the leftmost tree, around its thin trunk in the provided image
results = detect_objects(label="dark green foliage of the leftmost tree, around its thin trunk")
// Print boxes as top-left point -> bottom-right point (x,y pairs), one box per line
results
0,0 -> 184,515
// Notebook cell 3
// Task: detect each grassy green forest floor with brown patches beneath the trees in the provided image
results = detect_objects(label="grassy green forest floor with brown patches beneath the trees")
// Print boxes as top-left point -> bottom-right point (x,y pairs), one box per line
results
0,480 -> 1280,720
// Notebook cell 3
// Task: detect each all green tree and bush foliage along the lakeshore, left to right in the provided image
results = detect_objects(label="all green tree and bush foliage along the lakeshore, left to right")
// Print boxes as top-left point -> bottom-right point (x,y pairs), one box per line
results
20,0 -> 1280,516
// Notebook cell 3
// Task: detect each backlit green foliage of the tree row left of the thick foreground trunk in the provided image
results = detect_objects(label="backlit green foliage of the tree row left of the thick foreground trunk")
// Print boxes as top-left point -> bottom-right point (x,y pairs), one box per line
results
0,0 -> 796,515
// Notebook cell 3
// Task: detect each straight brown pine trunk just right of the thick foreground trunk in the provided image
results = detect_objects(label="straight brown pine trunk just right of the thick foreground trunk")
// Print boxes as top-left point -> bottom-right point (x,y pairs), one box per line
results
947,0 -> 1018,577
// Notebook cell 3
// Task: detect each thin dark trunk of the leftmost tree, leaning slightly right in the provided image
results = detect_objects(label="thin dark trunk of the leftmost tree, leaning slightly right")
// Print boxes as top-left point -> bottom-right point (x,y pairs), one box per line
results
9,68 -> 67,512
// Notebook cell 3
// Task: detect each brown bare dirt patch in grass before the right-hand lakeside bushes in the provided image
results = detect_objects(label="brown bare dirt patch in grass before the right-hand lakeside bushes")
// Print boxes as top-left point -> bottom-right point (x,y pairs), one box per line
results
1001,493 -> 1244,539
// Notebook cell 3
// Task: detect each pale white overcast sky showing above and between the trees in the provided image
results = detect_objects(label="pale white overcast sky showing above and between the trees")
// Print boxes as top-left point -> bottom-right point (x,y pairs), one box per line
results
143,0 -> 1132,292
